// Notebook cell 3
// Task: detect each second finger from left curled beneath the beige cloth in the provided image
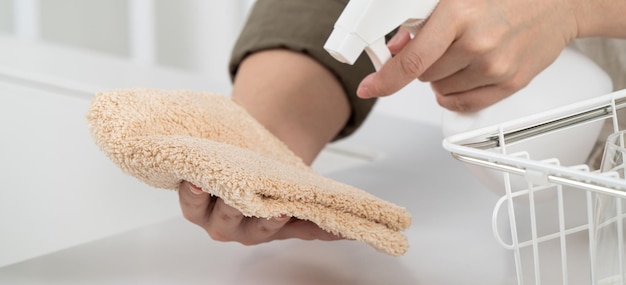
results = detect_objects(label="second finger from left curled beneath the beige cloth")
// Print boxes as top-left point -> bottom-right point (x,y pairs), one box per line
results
204,199 -> 245,241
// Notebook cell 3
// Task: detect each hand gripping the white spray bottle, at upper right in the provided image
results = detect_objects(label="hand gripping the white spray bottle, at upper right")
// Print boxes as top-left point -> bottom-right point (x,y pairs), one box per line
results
357,0 -> 577,112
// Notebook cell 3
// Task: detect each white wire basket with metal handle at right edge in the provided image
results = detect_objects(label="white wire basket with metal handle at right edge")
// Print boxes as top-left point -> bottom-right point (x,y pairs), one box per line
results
443,90 -> 626,285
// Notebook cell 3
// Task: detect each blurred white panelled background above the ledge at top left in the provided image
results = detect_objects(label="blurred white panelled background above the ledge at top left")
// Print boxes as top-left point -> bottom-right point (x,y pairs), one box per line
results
7,0 -> 253,83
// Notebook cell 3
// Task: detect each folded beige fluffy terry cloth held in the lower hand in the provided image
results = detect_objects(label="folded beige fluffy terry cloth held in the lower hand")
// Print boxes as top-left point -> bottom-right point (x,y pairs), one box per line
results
87,89 -> 411,255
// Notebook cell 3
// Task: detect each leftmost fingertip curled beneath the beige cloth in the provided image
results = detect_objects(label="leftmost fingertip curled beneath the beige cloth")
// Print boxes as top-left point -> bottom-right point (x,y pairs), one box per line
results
178,181 -> 211,225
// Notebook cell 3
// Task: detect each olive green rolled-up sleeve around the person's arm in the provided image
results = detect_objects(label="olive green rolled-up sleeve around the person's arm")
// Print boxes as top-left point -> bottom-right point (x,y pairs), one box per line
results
229,0 -> 375,139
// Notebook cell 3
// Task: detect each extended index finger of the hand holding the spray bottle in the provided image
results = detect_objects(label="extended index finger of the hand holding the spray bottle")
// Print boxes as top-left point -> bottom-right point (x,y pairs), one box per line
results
357,9 -> 457,98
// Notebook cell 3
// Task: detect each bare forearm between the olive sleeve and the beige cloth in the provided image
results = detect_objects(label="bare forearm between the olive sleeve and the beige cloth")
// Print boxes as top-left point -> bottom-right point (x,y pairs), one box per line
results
232,49 -> 350,164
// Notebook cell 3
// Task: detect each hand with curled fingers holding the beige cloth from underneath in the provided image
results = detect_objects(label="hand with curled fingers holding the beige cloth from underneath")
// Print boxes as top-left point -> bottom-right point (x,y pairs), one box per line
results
178,181 -> 341,245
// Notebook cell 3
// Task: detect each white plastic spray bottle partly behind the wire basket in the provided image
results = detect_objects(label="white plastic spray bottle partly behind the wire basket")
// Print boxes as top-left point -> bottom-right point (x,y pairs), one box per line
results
324,0 -> 612,193
